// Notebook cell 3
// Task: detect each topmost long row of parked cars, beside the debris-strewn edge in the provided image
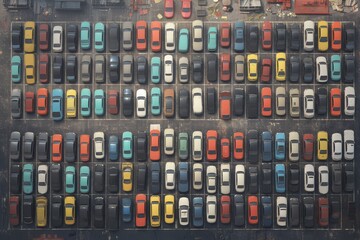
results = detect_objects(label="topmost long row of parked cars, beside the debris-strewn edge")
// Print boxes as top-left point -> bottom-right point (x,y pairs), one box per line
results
12,20 -> 355,53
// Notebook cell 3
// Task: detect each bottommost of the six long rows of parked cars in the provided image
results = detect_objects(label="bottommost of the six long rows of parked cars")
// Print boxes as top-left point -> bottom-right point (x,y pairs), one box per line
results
9,194 -> 342,229
